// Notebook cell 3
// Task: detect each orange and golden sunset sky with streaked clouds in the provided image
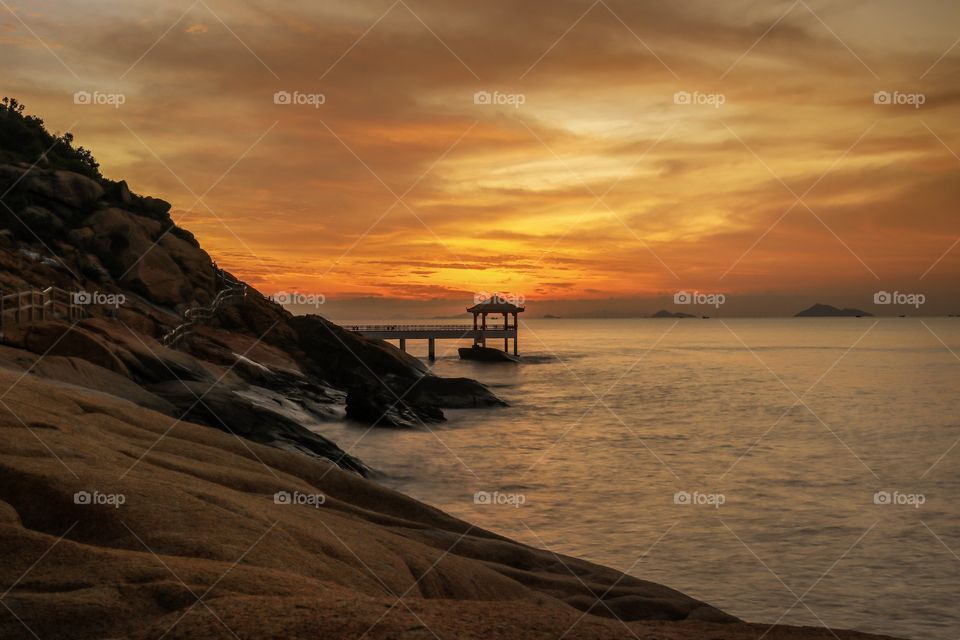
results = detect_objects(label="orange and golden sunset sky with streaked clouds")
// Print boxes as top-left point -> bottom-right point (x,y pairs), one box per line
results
0,0 -> 960,318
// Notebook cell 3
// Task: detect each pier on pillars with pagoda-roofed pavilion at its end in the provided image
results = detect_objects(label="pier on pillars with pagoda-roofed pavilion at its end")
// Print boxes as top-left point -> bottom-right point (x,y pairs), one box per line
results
344,297 -> 523,360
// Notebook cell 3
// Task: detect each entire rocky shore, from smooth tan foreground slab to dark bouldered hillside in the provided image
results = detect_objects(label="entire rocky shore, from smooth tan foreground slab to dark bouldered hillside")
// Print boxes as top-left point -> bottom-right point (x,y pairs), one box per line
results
0,107 -> 900,640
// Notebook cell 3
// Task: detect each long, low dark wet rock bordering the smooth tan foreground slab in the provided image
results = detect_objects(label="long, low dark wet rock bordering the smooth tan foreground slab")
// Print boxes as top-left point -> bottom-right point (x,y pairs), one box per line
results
147,381 -> 371,476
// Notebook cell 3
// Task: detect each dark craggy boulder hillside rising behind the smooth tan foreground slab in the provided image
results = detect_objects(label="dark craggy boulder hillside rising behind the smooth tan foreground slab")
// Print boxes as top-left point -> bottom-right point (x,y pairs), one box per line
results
0,109 -> 503,473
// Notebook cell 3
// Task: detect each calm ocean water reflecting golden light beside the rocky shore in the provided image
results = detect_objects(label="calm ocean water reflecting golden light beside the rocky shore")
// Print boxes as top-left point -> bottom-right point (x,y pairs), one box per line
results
312,318 -> 960,639
